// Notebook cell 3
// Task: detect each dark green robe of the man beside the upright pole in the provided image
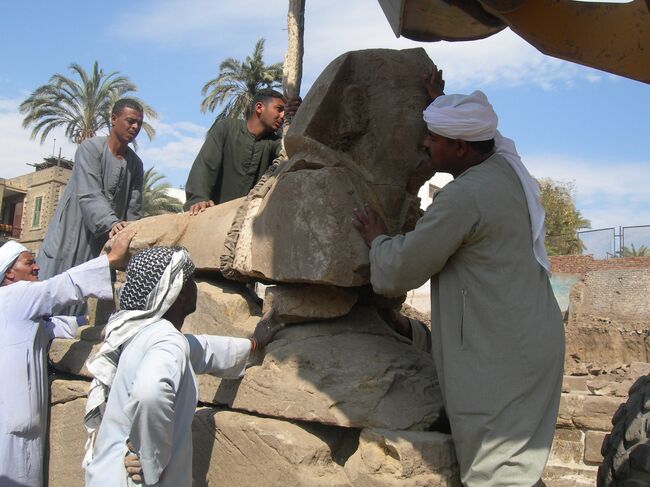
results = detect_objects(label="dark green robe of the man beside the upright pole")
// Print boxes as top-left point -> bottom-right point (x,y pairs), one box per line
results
185,119 -> 281,210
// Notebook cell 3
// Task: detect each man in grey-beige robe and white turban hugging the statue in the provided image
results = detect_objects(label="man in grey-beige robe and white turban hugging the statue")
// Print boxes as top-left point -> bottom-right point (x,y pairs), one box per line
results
355,82 -> 564,487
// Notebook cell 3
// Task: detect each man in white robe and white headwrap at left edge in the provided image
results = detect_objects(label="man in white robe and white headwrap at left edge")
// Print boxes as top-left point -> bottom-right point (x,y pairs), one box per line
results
0,235 -> 131,487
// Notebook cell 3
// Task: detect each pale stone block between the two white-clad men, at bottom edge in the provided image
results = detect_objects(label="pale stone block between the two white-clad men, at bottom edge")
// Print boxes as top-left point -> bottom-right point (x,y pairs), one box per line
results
48,396 -> 87,487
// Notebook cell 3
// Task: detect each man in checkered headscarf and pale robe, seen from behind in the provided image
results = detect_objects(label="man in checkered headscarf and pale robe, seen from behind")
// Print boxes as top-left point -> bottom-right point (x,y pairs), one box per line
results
84,247 -> 277,487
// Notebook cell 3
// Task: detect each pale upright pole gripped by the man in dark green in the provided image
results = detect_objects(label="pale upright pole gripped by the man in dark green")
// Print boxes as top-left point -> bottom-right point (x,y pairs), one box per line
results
282,0 -> 305,134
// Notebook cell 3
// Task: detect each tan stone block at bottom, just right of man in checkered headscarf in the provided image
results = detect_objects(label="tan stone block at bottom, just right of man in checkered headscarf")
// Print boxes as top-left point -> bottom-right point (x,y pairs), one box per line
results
192,408 -> 352,487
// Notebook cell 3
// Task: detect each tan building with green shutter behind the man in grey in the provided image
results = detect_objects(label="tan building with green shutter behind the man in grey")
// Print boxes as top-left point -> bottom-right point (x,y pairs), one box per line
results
0,157 -> 73,253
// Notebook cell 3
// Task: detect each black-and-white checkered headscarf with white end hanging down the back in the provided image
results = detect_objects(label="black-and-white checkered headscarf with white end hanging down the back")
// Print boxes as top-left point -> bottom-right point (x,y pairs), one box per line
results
83,247 -> 194,467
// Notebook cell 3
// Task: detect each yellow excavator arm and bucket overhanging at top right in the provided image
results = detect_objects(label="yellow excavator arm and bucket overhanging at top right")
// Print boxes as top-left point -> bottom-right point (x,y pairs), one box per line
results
379,0 -> 650,83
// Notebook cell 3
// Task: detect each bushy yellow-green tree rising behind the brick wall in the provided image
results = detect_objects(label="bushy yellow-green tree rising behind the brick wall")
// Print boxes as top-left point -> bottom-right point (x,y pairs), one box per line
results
538,178 -> 591,255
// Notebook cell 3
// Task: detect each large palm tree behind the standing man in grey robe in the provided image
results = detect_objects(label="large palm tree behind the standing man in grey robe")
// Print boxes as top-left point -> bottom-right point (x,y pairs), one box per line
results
20,61 -> 158,144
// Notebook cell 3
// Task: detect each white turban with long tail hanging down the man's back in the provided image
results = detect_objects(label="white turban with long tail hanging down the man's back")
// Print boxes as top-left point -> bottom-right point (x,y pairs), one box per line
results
423,91 -> 551,274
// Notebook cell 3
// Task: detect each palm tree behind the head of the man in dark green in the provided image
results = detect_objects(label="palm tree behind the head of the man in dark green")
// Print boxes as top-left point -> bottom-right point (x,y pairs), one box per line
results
201,38 -> 282,120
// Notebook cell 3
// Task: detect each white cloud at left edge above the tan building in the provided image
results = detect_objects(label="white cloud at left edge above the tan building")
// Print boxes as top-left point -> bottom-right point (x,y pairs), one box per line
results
0,98 -> 76,178
